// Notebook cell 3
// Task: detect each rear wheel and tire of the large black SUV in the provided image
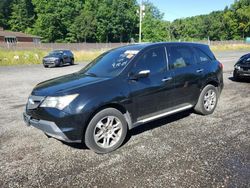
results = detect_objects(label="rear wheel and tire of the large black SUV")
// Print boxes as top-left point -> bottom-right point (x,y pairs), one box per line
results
194,85 -> 219,115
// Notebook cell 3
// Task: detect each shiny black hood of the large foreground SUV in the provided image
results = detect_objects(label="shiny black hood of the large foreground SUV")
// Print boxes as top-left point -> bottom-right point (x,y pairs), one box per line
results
32,73 -> 108,96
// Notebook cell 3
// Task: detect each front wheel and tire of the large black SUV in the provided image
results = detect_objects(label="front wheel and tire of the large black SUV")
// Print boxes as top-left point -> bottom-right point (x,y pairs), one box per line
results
84,108 -> 127,154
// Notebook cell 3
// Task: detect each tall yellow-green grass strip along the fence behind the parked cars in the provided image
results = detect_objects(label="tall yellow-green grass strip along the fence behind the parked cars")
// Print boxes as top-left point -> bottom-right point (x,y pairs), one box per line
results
0,44 -> 250,66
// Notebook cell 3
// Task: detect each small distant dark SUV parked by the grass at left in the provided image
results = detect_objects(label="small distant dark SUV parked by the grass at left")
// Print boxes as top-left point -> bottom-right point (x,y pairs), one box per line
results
43,50 -> 74,67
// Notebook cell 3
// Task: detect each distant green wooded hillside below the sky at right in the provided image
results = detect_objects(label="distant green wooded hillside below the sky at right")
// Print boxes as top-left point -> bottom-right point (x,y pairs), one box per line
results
171,0 -> 250,40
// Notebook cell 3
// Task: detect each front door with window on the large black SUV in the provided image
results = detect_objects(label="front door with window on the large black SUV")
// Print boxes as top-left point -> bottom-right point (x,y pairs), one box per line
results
129,47 -> 173,121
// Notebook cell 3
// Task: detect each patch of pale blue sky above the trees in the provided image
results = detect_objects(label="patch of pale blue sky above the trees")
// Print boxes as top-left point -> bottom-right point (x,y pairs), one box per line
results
150,0 -> 234,21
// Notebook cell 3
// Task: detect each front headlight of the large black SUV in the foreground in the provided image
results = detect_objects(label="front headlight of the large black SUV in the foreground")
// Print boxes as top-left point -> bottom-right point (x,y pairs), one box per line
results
40,94 -> 79,110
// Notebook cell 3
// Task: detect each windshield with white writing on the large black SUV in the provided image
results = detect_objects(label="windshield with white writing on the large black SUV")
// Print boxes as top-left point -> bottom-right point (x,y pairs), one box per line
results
80,49 -> 139,77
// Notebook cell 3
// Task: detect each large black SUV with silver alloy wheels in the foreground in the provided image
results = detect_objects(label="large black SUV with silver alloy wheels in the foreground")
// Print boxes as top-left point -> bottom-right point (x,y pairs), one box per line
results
23,43 -> 223,153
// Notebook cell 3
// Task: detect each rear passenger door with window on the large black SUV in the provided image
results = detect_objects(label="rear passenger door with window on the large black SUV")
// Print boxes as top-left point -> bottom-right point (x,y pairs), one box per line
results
168,44 -> 204,107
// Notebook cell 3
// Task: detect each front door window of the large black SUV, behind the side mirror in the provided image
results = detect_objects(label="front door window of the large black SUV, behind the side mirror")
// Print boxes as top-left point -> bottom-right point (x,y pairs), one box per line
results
134,47 -> 167,74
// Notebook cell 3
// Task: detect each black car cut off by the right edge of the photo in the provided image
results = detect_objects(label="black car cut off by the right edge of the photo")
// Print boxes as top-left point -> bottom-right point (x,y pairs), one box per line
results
233,53 -> 250,80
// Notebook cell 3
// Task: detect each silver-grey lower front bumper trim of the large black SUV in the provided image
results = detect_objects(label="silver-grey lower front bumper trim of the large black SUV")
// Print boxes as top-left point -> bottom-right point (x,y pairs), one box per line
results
23,112 -> 81,143
